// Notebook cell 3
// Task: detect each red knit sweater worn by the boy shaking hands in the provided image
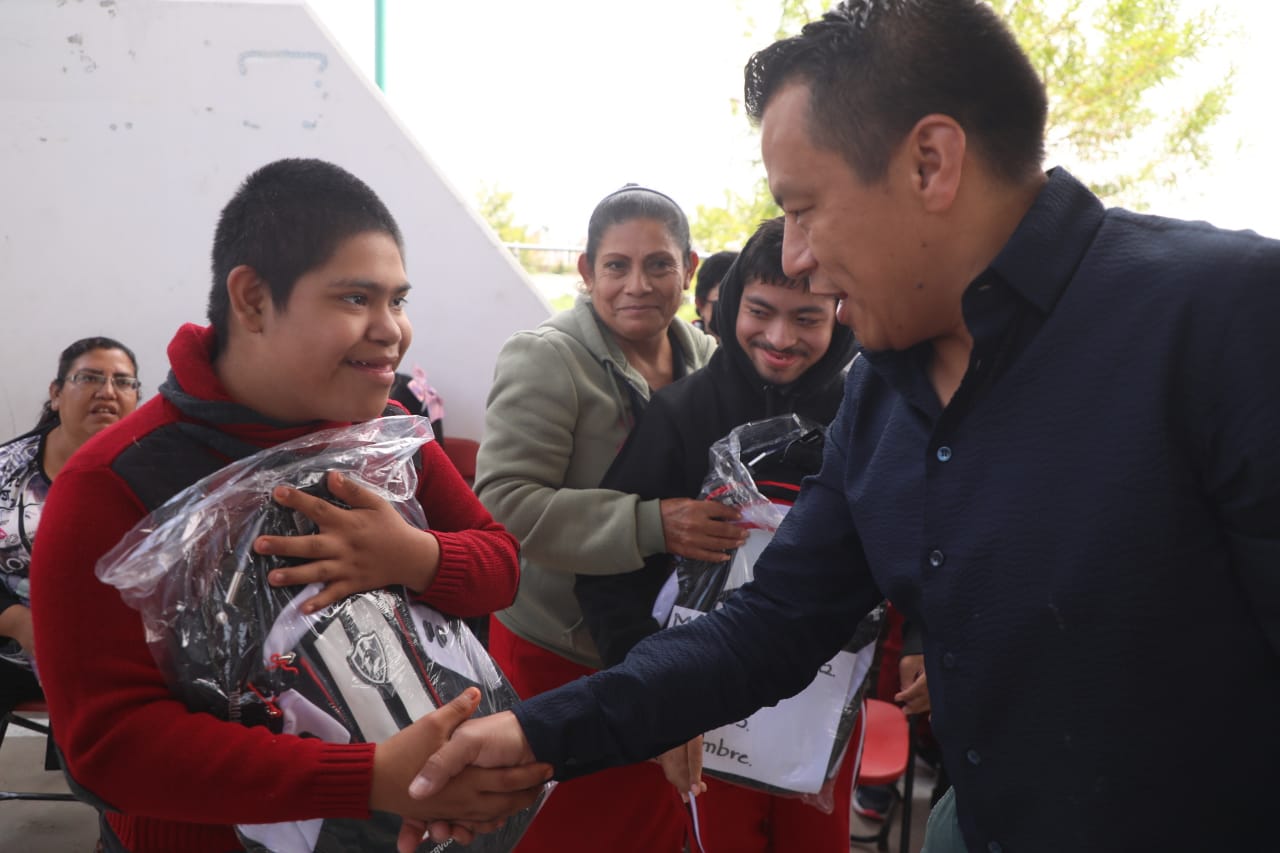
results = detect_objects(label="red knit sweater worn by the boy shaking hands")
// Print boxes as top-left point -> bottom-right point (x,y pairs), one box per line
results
31,325 -> 518,853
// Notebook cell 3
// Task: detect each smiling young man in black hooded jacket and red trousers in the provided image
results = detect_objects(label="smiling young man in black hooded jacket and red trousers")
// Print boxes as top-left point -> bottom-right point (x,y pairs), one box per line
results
575,218 -> 856,853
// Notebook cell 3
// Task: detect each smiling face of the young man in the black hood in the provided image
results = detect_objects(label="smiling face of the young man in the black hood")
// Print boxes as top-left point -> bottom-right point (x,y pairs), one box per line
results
735,279 -> 836,386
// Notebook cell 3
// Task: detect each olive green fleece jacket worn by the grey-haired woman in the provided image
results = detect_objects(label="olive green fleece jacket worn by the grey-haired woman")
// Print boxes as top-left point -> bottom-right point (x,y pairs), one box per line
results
475,298 -> 716,667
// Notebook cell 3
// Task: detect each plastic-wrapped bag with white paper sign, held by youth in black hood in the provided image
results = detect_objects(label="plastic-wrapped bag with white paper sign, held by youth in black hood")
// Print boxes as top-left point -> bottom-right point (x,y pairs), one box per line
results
654,415 -> 883,812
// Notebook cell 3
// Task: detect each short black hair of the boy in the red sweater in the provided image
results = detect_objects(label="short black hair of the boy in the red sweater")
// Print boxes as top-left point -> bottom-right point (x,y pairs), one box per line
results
209,159 -> 404,353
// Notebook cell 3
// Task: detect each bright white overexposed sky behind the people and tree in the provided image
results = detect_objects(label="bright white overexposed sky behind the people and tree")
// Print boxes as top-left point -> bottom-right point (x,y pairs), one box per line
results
308,0 -> 1280,245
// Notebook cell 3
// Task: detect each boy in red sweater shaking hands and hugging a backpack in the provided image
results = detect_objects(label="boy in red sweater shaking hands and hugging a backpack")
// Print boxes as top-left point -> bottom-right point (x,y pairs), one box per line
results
31,160 -> 549,853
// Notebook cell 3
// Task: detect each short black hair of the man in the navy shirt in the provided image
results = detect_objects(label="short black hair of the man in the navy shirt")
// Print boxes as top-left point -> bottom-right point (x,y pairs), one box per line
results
745,0 -> 1048,183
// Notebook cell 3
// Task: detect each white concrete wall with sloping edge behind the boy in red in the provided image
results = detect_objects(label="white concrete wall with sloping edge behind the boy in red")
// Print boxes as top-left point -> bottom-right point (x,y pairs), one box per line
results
0,0 -> 548,441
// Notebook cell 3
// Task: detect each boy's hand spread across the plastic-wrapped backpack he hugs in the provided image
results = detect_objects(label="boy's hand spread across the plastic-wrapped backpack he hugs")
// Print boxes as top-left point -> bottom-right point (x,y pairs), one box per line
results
253,471 -> 440,613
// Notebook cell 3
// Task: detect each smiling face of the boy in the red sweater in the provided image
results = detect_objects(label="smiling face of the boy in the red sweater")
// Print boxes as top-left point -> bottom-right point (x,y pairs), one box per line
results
244,232 -> 413,423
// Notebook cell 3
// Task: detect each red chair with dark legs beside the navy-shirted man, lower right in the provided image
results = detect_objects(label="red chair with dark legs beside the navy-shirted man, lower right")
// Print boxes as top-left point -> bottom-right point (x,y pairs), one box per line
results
849,699 -> 914,853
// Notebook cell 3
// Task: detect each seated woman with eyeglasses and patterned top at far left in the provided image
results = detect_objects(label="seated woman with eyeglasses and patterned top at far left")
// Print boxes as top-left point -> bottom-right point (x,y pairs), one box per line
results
0,338 -> 140,716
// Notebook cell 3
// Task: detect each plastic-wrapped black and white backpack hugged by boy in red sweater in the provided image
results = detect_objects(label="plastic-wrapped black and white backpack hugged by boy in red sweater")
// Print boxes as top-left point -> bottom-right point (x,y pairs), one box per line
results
97,416 -> 545,853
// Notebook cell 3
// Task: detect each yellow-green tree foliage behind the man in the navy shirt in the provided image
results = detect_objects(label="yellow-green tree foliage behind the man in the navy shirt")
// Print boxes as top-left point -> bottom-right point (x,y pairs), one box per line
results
692,0 -> 1234,251
